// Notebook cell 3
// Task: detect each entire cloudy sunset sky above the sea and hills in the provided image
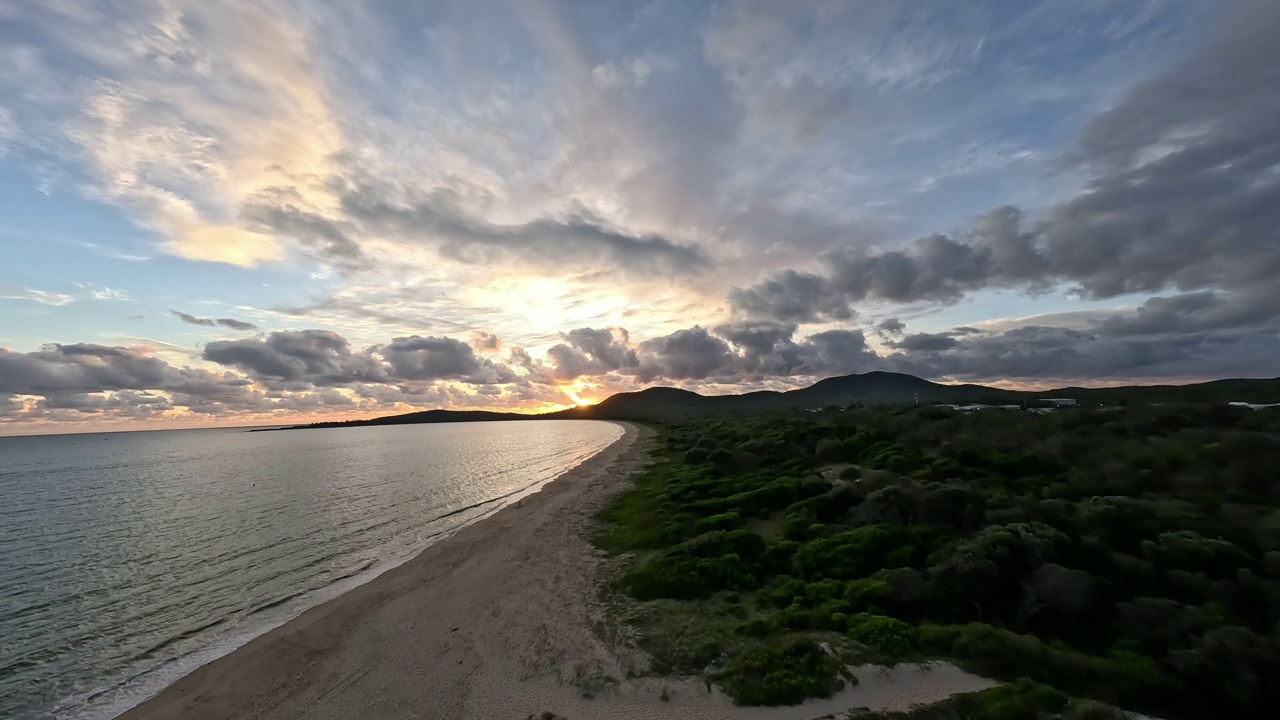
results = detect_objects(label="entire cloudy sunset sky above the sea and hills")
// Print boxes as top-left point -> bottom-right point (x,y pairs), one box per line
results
0,0 -> 1280,434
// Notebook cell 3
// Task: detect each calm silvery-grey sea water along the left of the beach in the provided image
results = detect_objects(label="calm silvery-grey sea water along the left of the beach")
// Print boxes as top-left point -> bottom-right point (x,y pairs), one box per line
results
0,420 -> 622,719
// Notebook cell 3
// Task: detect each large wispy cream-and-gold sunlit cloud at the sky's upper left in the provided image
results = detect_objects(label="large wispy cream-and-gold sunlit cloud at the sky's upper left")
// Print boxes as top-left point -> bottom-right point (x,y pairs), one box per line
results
0,0 -> 343,266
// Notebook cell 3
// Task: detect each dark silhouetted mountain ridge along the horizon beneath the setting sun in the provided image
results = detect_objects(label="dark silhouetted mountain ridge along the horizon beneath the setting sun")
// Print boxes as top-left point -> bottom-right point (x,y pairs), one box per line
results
277,372 -> 1280,429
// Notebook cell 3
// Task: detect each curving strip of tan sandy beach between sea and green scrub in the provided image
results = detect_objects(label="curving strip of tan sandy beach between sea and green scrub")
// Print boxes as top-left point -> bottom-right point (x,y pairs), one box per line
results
122,425 -> 991,720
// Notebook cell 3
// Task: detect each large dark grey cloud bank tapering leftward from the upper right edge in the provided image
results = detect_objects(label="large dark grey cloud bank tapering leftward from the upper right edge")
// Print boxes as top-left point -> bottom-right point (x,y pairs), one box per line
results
730,0 -> 1280,316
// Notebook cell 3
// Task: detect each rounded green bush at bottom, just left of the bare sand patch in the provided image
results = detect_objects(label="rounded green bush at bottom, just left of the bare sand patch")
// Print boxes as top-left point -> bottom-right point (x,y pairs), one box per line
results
712,638 -> 842,706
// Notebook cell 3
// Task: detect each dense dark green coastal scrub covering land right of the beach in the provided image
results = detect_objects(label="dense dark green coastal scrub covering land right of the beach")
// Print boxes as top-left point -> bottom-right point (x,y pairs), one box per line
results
598,404 -> 1280,719
